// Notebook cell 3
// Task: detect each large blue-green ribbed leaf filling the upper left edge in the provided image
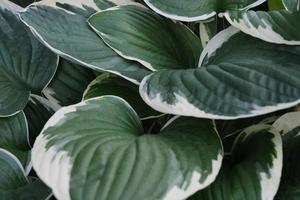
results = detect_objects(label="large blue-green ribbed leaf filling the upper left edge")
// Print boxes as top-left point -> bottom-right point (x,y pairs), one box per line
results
0,0 -> 58,116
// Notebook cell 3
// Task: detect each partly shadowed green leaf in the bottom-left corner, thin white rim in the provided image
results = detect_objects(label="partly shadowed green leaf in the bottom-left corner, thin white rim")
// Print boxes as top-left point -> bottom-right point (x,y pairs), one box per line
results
0,149 -> 51,200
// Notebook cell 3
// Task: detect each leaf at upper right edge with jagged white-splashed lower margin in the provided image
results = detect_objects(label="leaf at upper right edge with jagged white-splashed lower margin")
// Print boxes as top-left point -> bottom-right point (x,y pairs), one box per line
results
225,10 -> 300,45
